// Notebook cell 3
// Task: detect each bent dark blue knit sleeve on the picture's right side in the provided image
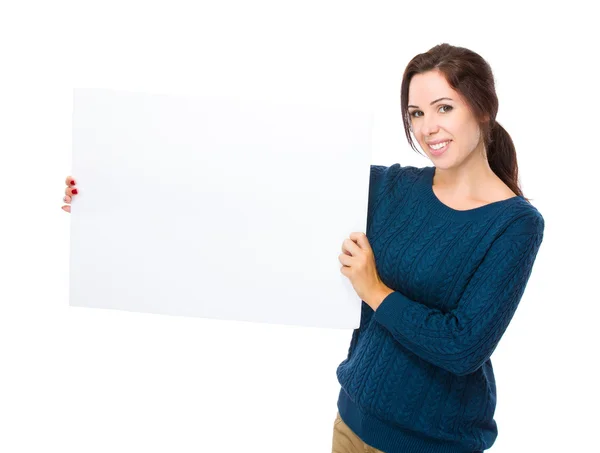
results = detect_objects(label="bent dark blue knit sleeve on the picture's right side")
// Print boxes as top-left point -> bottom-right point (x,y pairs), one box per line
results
374,212 -> 544,376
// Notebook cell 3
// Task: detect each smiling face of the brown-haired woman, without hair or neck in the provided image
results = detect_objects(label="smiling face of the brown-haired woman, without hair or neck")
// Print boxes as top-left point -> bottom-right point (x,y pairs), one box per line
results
408,71 -> 483,168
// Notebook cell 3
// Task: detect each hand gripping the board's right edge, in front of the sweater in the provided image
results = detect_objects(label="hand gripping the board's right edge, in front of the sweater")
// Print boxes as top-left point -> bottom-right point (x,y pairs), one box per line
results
339,233 -> 393,310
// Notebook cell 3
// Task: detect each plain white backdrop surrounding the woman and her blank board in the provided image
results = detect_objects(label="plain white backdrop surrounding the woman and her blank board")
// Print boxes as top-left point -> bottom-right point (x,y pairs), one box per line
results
0,0 -> 600,453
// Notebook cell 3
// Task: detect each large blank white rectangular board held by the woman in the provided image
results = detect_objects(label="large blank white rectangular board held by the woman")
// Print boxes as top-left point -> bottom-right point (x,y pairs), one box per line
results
70,88 -> 373,328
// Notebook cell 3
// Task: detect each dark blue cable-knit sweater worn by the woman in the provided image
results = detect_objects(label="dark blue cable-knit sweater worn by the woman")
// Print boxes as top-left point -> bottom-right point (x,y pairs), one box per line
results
337,164 -> 544,453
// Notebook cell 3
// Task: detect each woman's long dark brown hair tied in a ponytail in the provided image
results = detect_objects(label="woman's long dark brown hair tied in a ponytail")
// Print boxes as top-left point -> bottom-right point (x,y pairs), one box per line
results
400,43 -> 529,201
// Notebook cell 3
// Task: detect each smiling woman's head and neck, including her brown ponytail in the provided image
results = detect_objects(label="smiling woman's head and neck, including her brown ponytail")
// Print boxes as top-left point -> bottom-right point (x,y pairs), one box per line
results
401,44 -> 523,202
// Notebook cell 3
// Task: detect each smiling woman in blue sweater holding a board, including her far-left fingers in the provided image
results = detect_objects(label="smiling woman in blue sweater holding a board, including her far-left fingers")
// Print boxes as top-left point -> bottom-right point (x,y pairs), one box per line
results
63,44 -> 544,453
